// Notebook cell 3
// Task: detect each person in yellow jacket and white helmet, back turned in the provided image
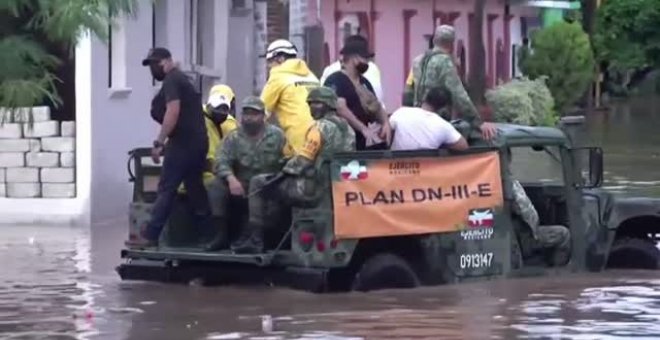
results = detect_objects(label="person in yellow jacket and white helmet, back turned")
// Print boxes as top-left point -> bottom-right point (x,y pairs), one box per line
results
261,39 -> 321,158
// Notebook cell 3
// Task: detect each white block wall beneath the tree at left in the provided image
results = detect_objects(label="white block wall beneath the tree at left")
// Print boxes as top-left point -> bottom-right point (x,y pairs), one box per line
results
0,106 -> 76,198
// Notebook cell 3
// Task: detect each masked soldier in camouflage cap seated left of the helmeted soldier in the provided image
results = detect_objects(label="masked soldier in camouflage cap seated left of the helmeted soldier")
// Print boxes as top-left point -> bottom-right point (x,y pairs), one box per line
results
207,97 -> 286,251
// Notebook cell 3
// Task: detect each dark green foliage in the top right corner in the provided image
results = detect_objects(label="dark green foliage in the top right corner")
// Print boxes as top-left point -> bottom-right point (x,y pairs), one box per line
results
594,0 -> 660,72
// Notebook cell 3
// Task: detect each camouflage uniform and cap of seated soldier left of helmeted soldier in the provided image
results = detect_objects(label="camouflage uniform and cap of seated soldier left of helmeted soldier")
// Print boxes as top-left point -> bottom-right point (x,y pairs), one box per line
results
209,97 -> 286,248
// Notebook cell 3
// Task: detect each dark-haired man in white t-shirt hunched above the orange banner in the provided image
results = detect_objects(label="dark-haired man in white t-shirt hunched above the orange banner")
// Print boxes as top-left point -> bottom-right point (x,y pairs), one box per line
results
390,88 -> 468,150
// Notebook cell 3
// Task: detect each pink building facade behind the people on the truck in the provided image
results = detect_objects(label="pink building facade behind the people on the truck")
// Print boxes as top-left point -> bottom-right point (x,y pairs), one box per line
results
313,0 -> 539,108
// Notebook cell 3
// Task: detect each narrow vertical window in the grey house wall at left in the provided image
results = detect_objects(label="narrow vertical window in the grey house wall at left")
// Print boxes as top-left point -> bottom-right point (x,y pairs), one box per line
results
108,19 -> 127,89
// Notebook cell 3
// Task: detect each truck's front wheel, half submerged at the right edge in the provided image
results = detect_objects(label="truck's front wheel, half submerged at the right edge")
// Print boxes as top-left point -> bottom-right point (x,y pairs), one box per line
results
607,237 -> 660,269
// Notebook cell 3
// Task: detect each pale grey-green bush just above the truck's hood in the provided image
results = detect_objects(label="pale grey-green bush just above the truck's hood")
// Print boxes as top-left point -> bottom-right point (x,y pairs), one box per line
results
486,77 -> 558,126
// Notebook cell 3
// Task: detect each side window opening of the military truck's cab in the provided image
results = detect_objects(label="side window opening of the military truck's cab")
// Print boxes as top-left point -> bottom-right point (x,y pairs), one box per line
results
509,146 -> 564,185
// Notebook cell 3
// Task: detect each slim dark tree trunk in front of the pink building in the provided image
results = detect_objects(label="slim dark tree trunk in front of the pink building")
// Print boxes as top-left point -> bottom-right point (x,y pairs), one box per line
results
468,0 -> 486,106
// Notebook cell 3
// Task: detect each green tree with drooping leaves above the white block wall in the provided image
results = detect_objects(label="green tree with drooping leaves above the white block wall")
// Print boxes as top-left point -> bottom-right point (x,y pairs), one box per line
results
0,0 -> 137,121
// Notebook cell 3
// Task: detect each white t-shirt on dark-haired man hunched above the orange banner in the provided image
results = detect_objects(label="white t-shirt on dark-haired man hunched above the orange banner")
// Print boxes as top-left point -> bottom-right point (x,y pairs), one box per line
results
390,106 -> 462,150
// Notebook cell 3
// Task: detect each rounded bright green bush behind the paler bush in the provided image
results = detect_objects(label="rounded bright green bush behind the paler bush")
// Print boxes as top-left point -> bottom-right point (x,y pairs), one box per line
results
521,22 -> 594,113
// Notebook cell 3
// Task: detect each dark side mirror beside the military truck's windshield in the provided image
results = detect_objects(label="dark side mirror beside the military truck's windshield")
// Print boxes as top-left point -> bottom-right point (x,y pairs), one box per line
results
571,147 -> 604,189
